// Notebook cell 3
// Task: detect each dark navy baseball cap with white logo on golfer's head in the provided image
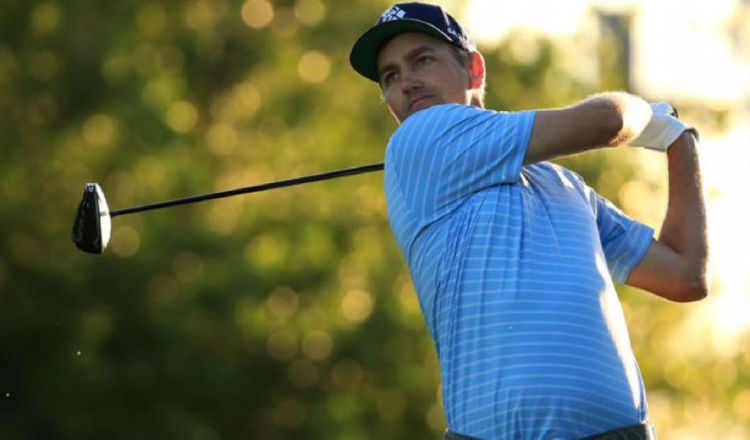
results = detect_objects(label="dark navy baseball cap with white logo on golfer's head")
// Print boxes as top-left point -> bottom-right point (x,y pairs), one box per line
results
349,2 -> 477,82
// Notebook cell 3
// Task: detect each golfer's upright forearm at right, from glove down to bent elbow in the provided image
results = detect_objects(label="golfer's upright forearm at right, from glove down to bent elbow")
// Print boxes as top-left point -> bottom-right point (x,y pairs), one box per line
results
659,132 -> 708,291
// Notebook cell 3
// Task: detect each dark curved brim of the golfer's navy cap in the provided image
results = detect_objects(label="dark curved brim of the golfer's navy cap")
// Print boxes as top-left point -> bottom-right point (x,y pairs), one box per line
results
349,19 -> 452,82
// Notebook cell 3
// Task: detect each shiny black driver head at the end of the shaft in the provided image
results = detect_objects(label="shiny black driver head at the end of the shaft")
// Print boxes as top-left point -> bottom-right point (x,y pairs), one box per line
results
73,183 -> 112,254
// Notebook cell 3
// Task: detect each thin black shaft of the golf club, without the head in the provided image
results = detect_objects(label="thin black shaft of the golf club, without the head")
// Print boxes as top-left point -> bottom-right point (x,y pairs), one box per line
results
109,163 -> 383,217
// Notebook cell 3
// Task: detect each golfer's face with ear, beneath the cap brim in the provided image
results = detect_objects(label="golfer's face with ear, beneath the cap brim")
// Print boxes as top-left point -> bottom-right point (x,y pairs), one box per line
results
377,32 -> 471,122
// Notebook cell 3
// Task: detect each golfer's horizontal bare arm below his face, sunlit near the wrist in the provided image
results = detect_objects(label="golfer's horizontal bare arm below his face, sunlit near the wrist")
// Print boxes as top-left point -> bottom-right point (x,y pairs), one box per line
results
524,92 -> 652,164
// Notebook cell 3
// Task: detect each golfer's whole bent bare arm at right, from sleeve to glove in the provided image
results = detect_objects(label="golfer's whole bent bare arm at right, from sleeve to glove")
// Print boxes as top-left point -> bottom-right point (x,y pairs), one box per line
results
627,132 -> 708,301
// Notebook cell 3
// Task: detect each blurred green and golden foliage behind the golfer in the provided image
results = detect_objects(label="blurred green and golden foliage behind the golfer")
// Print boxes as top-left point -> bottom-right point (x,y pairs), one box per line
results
0,0 -> 750,440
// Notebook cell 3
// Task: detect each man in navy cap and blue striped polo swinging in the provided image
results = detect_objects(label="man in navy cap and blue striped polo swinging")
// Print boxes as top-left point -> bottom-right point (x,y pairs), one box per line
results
350,3 -> 707,439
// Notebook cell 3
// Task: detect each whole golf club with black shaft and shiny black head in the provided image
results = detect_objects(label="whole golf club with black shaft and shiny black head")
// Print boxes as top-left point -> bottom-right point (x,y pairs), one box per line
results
72,163 -> 383,254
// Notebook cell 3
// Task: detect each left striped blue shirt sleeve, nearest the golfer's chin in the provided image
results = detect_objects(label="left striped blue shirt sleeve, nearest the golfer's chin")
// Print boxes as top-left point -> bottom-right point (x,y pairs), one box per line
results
385,104 -> 535,223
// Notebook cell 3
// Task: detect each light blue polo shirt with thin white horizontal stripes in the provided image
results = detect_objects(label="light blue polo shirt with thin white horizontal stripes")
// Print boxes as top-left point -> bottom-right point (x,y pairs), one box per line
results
385,104 -> 653,439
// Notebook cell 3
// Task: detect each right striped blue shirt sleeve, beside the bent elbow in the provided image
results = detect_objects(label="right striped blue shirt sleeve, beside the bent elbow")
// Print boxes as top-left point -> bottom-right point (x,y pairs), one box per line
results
589,188 -> 654,284
